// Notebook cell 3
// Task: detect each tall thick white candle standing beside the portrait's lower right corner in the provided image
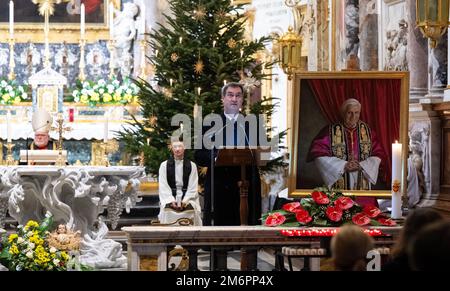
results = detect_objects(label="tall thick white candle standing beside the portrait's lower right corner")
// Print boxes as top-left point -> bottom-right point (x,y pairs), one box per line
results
391,141 -> 402,219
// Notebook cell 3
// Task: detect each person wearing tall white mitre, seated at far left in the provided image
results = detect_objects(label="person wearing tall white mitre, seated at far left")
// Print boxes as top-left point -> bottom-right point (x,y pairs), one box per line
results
29,108 -> 56,150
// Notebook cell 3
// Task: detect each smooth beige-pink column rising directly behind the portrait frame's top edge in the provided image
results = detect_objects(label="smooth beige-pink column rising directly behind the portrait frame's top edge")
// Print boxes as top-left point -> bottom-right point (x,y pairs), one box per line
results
359,0 -> 378,71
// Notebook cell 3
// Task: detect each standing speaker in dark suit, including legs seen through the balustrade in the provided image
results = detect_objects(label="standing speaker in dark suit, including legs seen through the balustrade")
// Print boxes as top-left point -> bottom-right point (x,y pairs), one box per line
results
195,83 -> 261,270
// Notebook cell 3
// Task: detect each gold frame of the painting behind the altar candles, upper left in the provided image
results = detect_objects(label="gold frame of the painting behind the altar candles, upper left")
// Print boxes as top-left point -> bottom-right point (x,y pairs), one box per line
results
0,0 -> 121,43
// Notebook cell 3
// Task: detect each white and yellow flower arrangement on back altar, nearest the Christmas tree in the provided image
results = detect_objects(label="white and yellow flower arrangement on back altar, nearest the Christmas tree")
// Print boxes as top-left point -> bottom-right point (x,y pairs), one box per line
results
72,79 -> 139,106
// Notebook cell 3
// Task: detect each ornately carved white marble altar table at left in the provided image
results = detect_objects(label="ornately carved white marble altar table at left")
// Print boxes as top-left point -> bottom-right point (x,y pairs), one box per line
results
0,166 -> 144,268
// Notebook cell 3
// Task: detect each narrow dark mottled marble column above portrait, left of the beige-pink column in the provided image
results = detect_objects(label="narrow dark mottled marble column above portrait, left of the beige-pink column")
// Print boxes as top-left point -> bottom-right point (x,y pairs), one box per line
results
344,0 -> 359,59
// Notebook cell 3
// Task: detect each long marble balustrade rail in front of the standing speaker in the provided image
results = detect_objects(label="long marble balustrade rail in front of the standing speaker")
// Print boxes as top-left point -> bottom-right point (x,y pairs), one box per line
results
122,226 -> 401,271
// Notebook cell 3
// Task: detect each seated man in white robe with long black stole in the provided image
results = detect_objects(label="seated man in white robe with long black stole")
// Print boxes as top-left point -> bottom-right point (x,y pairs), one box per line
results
158,139 -> 202,225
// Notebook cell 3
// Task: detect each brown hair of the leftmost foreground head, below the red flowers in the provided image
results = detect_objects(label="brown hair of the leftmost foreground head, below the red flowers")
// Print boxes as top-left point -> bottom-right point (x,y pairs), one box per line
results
331,224 -> 374,271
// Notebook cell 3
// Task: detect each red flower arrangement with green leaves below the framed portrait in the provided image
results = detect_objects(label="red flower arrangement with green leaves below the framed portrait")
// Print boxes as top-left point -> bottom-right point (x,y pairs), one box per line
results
262,188 -> 396,227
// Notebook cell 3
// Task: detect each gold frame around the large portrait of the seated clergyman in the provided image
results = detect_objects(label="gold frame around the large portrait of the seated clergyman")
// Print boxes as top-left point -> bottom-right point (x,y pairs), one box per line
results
288,71 -> 409,198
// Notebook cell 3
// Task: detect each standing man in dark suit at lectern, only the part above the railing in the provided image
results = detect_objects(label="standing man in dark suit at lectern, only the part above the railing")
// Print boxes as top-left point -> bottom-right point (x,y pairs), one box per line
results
195,83 -> 261,225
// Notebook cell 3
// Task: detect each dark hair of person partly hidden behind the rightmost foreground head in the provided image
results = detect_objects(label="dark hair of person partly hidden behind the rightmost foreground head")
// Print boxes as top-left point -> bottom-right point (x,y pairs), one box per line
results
391,207 -> 443,258
